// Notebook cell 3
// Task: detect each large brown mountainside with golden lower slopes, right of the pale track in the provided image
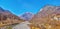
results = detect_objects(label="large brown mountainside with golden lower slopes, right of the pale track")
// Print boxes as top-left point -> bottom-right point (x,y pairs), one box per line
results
30,5 -> 60,29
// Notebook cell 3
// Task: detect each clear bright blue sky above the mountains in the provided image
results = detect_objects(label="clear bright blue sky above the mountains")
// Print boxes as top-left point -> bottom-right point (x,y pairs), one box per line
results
0,0 -> 60,15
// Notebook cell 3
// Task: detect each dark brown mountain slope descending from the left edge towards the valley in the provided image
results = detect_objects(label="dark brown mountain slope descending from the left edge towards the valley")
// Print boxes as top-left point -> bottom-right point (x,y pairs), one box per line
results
0,7 -> 24,26
